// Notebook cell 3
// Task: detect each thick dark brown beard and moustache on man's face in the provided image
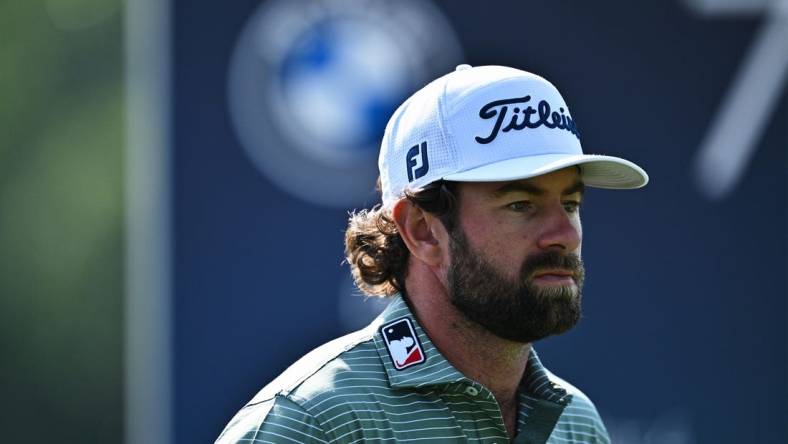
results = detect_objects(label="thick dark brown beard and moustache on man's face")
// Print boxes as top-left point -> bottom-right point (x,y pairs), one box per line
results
447,228 -> 585,343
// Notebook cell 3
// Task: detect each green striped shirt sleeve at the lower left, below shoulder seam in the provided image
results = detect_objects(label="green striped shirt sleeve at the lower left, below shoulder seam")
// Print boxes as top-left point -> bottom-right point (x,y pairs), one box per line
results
216,396 -> 328,444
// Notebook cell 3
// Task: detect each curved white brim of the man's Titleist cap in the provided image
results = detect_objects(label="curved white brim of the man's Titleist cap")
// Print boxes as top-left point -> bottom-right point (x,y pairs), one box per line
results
443,154 -> 648,189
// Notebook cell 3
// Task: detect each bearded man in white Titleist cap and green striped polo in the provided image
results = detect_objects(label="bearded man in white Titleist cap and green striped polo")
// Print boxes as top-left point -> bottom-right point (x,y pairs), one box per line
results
218,65 -> 648,443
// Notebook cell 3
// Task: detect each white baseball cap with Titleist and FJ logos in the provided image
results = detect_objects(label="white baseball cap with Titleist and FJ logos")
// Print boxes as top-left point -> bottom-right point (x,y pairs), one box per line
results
378,65 -> 648,207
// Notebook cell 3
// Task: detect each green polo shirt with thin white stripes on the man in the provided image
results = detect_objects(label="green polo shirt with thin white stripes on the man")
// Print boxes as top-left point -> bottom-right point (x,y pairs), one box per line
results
216,296 -> 610,444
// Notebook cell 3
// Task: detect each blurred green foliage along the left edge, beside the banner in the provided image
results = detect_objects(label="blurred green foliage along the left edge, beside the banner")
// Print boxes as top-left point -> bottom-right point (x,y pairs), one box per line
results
0,0 -> 123,443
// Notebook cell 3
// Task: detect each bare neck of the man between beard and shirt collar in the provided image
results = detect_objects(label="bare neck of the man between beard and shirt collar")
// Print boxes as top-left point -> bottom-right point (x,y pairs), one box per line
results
406,267 -> 531,436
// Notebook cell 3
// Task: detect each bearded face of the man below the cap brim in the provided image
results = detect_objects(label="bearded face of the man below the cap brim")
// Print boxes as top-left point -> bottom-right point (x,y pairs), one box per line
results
447,167 -> 584,343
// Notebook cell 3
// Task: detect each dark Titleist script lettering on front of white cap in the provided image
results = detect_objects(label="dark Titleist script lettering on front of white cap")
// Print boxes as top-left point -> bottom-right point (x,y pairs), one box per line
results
476,96 -> 580,144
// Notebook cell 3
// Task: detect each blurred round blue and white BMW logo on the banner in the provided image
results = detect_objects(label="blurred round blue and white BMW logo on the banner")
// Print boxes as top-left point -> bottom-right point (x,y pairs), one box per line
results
228,0 -> 462,207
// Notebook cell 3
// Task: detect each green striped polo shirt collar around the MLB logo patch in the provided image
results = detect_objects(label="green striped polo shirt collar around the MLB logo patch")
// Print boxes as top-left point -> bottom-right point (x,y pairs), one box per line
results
369,294 -> 571,404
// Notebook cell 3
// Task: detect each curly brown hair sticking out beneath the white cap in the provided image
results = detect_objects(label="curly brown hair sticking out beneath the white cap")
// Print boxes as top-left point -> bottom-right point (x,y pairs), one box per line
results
345,179 -> 459,297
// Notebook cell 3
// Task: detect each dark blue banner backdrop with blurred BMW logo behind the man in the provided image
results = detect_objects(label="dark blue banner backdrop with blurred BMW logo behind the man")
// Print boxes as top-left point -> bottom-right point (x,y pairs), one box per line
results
173,0 -> 788,443
